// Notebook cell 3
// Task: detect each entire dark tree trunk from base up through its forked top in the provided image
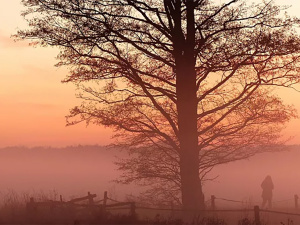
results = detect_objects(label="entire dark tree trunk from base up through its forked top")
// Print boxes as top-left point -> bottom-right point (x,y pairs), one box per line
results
173,0 -> 204,214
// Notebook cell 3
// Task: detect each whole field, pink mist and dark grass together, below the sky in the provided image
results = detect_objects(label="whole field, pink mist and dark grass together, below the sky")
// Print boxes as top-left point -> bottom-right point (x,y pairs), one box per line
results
0,146 -> 300,225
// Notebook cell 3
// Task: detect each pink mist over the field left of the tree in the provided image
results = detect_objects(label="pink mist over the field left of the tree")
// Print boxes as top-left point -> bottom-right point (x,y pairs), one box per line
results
0,146 -> 132,200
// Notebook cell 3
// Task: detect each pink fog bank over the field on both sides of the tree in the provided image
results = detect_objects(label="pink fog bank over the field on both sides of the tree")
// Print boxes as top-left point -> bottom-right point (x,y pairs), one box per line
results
0,146 -> 300,207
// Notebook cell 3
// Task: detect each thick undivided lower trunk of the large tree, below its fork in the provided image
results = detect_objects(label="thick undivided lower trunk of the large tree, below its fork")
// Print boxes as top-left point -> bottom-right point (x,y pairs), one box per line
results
177,62 -> 204,213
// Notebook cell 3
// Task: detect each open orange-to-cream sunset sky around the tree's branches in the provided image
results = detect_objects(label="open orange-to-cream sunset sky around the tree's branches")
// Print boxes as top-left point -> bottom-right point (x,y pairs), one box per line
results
0,0 -> 300,147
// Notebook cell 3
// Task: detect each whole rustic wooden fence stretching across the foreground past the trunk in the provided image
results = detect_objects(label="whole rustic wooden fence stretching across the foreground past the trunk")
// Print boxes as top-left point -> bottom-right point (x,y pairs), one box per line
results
23,192 -> 300,225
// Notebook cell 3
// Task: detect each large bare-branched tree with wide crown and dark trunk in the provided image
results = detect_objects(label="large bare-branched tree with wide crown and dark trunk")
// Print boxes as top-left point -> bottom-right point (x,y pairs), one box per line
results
17,0 -> 300,213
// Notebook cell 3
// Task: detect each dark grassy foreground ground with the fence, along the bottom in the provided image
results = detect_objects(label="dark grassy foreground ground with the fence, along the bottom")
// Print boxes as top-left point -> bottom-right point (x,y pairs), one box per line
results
0,192 -> 300,225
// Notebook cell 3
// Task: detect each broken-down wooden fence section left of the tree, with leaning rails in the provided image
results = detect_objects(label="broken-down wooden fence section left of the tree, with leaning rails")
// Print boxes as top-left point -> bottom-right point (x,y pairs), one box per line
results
26,191 -> 136,222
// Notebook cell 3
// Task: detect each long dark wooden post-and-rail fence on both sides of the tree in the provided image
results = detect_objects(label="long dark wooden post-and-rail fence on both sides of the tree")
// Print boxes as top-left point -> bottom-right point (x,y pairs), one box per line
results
27,192 -> 300,225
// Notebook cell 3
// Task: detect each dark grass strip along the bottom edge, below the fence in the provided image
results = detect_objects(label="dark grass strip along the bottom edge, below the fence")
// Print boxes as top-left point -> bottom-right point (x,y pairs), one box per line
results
0,190 -> 300,225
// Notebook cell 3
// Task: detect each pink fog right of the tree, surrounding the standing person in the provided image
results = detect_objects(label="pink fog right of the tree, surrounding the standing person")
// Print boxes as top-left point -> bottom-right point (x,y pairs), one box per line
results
204,146 -> 300,207
